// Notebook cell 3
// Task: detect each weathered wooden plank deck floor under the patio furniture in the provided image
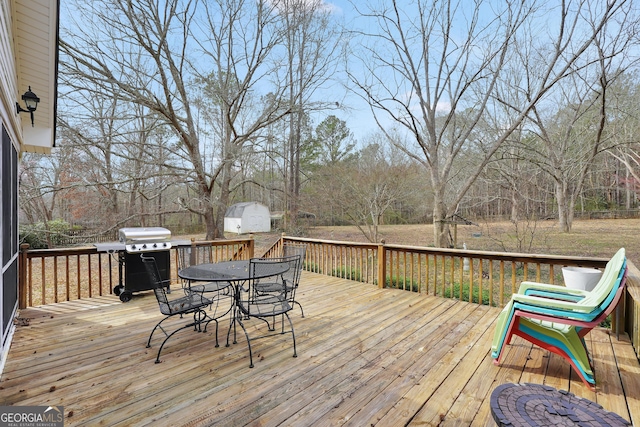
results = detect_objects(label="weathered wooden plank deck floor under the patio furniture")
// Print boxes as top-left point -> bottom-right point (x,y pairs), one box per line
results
0,272 -> 640,427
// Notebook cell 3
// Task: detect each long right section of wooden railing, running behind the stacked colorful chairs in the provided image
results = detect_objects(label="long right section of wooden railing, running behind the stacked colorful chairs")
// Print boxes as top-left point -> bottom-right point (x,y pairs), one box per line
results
266,236 -> 608,306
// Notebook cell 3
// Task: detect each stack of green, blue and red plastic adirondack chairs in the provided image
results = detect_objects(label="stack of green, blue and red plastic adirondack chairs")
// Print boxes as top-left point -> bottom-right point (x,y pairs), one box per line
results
492,248 -> 626,388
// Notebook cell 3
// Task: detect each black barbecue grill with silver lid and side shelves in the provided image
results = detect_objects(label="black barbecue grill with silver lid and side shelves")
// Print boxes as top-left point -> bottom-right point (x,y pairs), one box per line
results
95,227 -> 178,302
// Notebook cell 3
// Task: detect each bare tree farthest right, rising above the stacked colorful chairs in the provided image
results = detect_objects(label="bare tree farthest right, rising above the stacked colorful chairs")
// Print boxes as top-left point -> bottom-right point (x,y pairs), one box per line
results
530,4 -> 634,232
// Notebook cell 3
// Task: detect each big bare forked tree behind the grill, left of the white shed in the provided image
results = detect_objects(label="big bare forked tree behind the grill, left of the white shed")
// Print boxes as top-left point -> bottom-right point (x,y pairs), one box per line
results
60,0 -> 290,238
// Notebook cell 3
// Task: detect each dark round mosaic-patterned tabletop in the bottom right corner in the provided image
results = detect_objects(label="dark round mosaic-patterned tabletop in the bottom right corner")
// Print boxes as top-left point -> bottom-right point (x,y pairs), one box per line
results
491,383 -> 631,427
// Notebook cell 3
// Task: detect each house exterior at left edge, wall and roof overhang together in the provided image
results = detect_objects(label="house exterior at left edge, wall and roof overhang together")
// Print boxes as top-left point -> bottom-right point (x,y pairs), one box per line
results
0,0 -> 58,373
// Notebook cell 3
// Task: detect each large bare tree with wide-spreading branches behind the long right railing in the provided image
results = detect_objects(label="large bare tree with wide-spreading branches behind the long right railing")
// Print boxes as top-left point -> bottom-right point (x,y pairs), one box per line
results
351,0 -> 630,246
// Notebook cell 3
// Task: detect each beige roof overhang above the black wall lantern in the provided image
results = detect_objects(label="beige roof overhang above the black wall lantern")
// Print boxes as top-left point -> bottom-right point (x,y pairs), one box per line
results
13,0 -> 60,154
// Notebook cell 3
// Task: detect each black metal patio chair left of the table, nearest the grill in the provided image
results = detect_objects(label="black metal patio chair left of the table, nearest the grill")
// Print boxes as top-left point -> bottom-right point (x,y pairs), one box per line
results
140,254 -> 212,363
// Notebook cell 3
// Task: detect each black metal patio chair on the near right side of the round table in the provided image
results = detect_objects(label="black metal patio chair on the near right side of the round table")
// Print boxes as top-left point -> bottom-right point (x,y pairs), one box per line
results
227,256 -> 300,368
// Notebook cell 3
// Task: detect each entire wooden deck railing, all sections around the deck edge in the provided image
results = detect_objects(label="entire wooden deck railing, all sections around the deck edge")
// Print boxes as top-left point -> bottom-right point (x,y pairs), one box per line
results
19,235 -> 640,362
